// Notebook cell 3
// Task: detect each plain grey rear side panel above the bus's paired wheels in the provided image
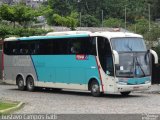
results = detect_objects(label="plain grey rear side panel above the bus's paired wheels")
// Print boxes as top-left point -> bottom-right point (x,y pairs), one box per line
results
4,55 -> 37,84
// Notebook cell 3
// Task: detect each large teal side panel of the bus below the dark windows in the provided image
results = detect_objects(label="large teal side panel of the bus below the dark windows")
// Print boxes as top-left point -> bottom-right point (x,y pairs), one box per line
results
32,55 -> 99,89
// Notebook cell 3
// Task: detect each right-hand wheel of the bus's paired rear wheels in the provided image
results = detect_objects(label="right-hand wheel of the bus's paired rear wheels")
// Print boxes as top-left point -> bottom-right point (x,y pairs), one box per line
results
26,76 -> 35,92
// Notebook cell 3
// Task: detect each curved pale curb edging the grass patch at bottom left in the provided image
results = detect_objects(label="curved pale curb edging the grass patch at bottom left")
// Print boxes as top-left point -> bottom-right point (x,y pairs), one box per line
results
0,102 -> 24,115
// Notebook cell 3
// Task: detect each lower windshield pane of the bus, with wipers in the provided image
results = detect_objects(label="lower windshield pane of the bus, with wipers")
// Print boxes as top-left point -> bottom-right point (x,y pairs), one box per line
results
116,52 -> 150,77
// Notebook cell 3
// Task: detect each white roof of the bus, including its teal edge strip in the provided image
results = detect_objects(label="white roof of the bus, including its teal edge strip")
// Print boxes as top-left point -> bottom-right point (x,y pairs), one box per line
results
4,31 -> 143,41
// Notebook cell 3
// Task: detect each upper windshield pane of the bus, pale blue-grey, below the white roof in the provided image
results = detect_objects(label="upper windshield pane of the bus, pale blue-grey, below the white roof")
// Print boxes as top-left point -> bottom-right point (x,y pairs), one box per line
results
111,38 -> 146,52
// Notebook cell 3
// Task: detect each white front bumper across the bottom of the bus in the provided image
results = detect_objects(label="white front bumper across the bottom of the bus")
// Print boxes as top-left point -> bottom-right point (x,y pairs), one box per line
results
115,83 -> 151,92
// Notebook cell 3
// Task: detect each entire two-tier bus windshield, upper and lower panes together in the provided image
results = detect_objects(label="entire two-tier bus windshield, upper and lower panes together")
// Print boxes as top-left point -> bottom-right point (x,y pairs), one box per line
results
111,38 -> 150,77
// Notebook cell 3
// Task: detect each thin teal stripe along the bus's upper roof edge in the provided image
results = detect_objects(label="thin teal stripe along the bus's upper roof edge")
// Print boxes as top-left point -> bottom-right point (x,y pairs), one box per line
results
17,34 -> 89,40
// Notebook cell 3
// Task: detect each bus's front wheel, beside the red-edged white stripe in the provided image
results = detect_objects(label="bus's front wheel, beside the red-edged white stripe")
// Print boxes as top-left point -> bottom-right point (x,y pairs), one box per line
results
90,80 -> 101,97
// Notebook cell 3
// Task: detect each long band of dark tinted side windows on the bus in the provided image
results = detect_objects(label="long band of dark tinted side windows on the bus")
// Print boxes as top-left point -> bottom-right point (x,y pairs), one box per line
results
4,37 -> 96,55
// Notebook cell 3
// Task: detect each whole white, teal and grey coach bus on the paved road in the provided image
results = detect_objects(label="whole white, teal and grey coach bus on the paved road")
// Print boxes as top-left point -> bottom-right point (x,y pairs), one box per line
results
3,31 -> 158,96
